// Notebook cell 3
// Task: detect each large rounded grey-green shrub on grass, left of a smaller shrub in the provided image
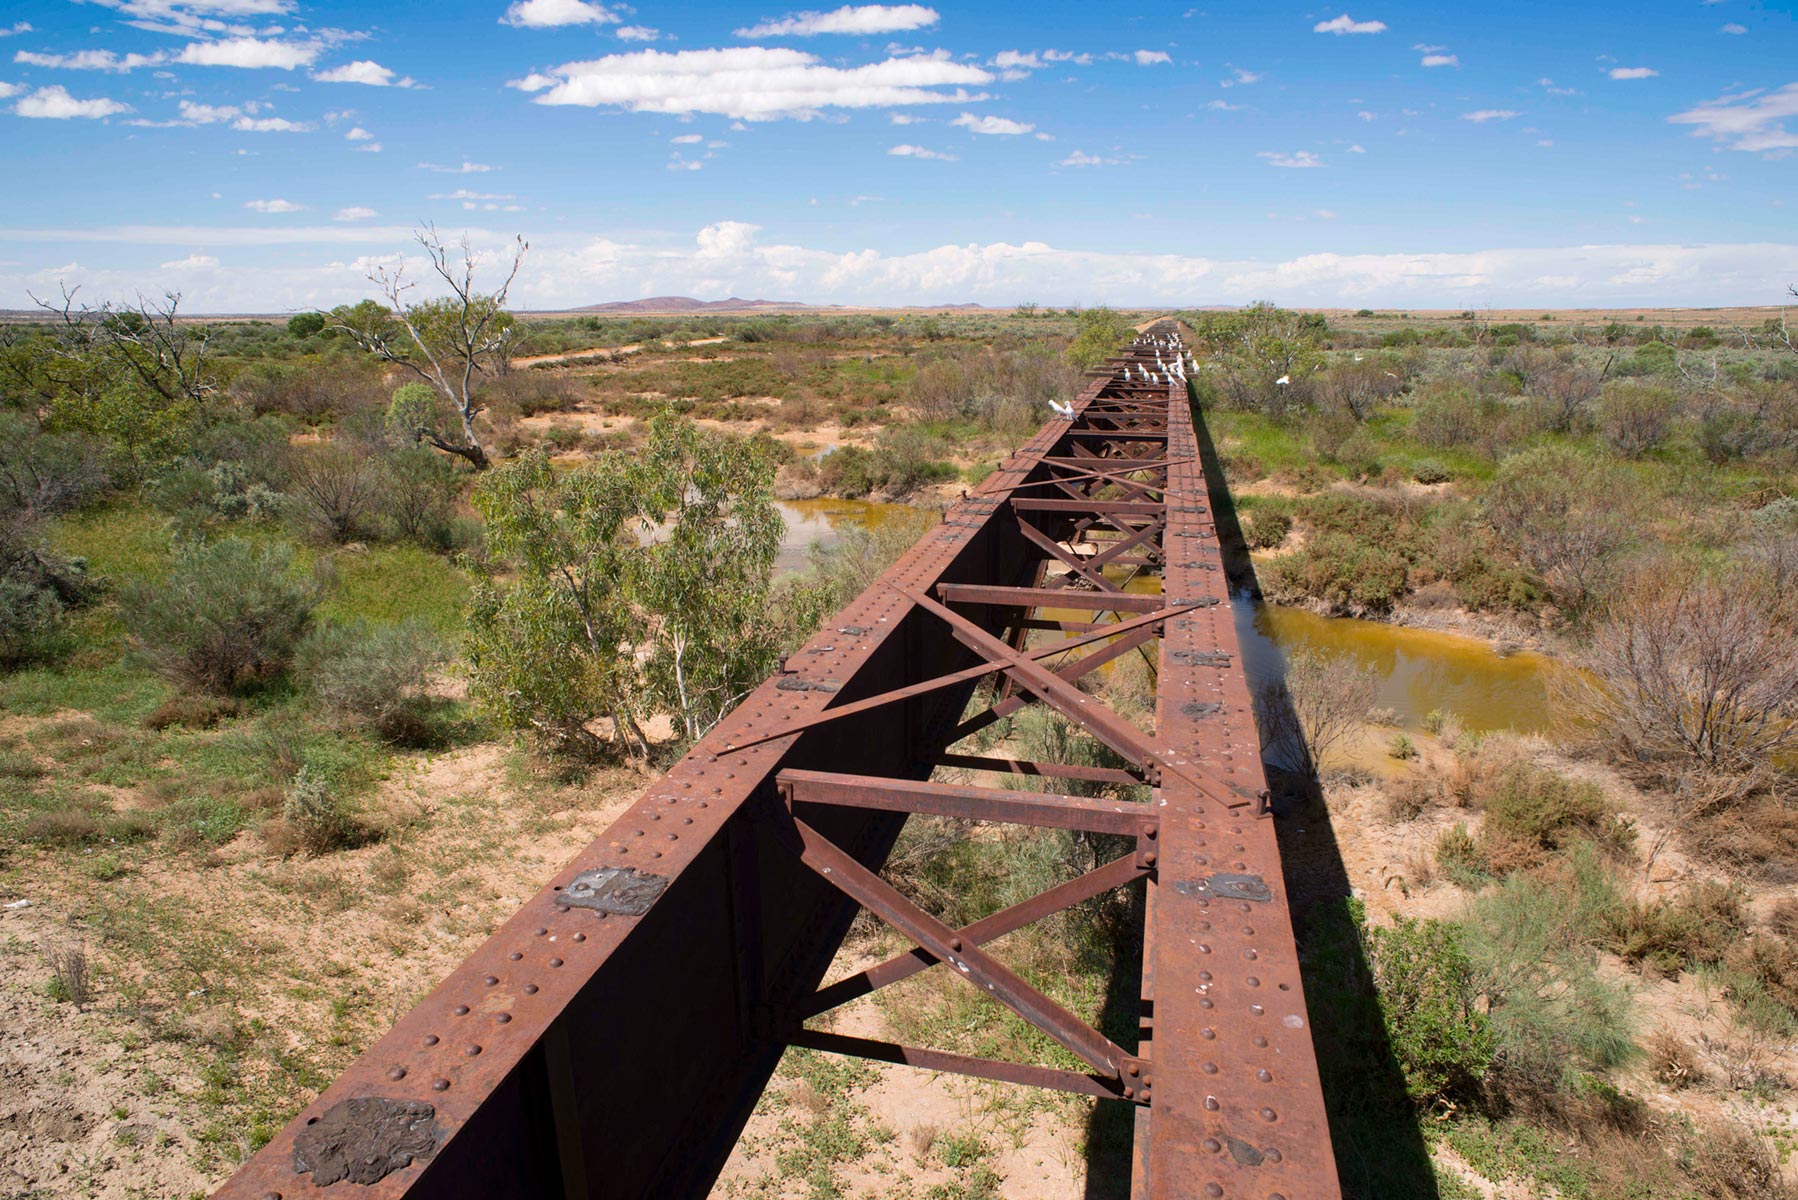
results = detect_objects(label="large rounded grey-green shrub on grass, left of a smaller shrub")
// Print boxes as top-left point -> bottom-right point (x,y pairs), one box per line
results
120,538 -> 318,694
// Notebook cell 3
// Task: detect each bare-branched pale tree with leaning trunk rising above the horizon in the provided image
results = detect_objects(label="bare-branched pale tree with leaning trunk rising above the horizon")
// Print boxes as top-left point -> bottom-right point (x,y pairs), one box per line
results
327,225 -> 529,468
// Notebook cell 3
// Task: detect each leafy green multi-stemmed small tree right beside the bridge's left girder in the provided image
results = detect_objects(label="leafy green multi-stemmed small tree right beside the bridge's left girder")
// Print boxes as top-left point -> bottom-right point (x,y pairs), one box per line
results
466,417 -> 782,754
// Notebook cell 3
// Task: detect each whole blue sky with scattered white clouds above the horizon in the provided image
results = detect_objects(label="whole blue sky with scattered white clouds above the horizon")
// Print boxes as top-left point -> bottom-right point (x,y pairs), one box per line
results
0,0 -> 1798,311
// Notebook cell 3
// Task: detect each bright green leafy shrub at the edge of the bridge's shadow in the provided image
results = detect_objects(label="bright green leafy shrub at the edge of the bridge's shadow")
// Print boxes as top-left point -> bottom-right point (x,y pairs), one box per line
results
1366,918 -> 1498,1105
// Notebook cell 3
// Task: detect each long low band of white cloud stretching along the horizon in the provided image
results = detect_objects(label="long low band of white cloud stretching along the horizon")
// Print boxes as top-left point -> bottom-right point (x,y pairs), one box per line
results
14,221 -> 1798,313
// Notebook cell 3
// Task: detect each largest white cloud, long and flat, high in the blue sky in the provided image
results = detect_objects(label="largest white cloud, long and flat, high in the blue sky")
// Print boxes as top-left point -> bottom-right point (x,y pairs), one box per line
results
509,47 -> 992,121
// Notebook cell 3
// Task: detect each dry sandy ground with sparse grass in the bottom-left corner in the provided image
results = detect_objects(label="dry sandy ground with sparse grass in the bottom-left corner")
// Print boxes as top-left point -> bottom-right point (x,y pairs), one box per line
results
0,745 -> 642,1200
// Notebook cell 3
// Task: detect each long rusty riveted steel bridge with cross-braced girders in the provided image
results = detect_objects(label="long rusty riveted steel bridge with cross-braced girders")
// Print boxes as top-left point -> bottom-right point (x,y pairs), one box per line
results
218,324 -> 1340,1200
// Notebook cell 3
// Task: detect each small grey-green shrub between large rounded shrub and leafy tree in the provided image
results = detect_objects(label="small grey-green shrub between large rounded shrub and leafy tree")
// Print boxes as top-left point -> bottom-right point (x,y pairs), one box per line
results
297,621 -> 446,745
